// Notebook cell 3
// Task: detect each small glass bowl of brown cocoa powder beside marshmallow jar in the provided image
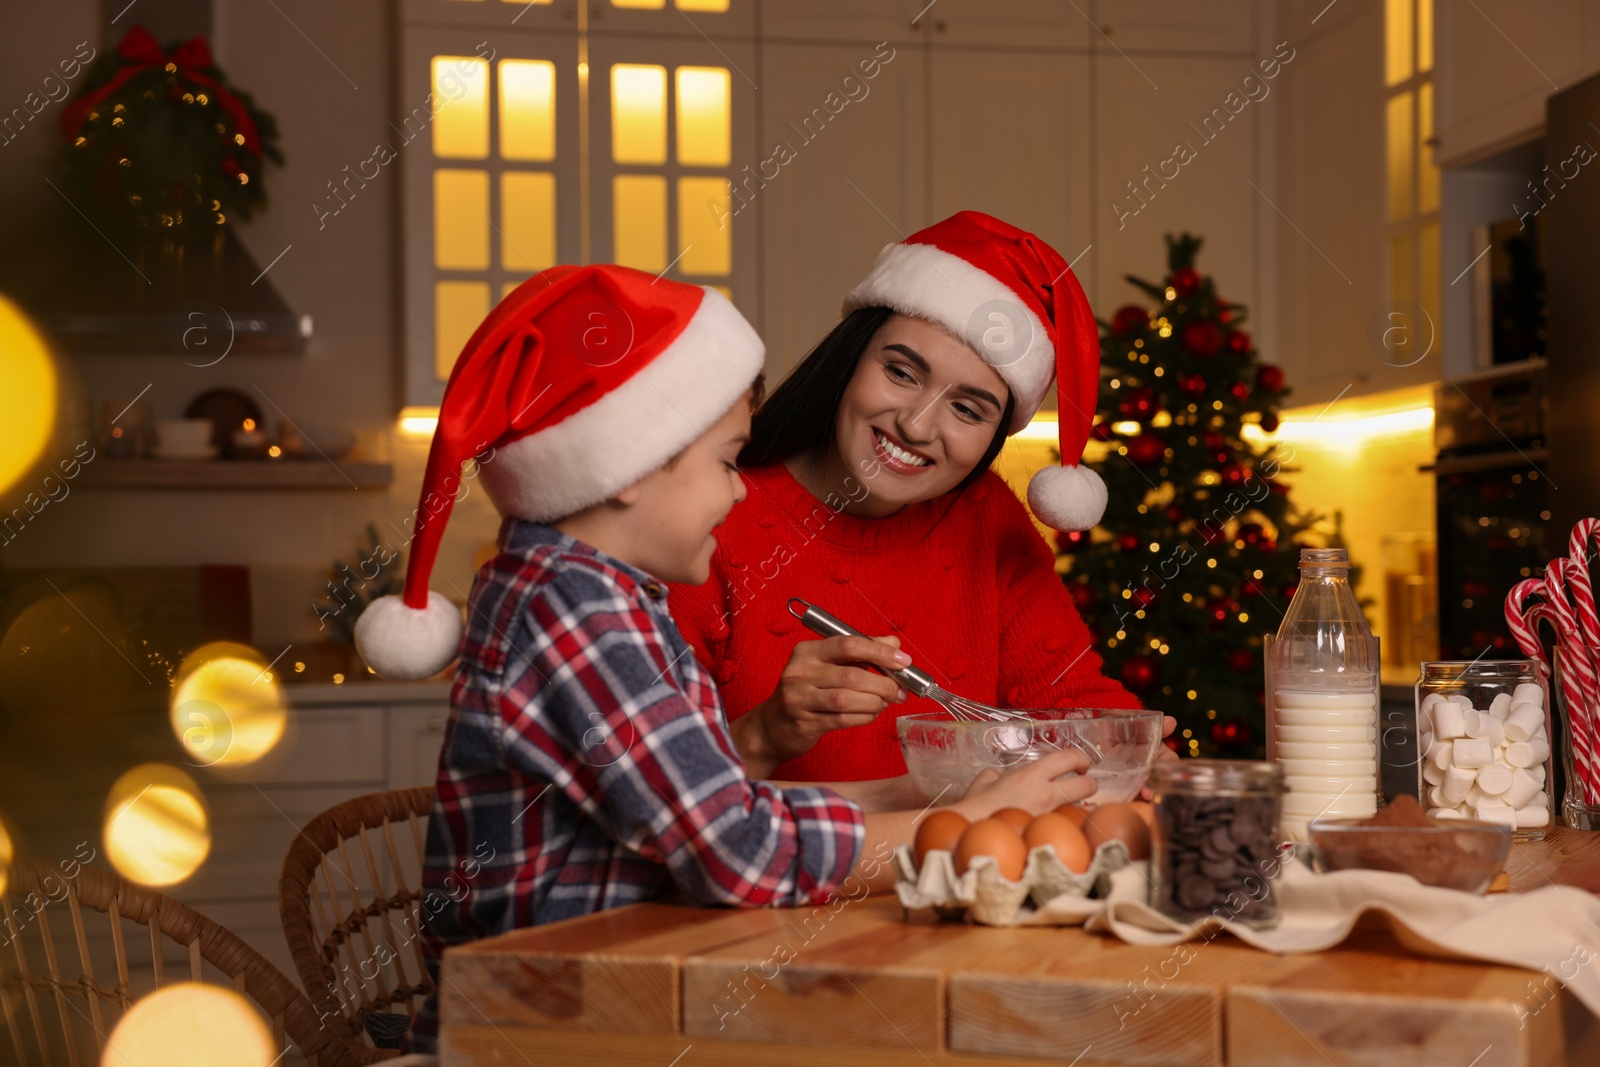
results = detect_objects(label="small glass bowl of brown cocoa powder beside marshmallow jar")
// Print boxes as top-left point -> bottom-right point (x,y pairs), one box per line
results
1309,795 -> 1510,894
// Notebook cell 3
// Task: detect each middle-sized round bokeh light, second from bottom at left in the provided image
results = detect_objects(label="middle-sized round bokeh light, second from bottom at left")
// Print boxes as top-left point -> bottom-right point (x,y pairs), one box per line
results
104,763 -> 211,886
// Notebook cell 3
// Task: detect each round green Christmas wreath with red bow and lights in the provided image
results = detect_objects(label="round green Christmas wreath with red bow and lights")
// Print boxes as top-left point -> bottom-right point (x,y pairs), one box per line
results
61,26 -> 283,237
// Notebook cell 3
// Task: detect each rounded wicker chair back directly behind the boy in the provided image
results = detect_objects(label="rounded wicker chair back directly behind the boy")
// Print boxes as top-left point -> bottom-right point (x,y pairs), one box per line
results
278,785 -> 434,1064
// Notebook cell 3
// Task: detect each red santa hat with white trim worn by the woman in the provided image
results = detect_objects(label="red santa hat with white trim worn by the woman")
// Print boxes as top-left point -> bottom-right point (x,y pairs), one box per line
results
845,211 -> 1106,530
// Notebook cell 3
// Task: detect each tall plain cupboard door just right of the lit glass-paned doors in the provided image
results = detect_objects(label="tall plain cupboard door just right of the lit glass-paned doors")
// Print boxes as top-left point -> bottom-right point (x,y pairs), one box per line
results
758,43 -> 930,387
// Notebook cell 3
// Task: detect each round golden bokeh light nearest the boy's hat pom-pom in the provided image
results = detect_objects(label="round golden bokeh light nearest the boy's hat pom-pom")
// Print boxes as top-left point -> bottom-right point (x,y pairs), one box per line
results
170,641 -> 288,766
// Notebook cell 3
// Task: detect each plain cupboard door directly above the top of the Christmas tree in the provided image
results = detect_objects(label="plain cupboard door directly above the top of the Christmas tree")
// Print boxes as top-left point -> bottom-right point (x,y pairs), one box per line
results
1094,54 -> 1267,335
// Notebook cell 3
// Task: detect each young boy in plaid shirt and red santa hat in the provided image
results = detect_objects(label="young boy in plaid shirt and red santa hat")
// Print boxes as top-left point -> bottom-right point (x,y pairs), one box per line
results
357,266 -> 1093,1051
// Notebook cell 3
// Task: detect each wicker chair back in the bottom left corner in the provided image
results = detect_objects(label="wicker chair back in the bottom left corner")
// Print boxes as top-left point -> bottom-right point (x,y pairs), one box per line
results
0,857 -> 350,1067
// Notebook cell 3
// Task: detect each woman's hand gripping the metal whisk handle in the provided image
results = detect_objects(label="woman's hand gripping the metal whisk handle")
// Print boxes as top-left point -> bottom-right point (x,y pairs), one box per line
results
731,637 -> 910,777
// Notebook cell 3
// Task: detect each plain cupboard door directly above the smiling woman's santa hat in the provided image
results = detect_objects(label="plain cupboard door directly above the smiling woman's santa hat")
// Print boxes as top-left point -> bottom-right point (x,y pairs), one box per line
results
928,48 -> 1093,283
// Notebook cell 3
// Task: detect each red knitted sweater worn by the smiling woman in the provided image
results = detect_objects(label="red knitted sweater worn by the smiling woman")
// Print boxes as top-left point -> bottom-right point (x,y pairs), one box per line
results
667,464 -> 1139,782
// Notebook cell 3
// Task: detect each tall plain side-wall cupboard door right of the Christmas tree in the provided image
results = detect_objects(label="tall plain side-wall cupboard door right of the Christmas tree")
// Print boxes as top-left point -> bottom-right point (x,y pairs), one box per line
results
1261,5 -> 1395,405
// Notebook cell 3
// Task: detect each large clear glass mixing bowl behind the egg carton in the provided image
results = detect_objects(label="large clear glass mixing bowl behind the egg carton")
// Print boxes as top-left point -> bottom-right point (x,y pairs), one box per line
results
896,707 -> 1162,805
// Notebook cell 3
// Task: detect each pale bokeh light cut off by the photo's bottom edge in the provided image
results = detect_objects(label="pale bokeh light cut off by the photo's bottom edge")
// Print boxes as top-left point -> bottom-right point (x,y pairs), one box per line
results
101,982 -> 278,1067
